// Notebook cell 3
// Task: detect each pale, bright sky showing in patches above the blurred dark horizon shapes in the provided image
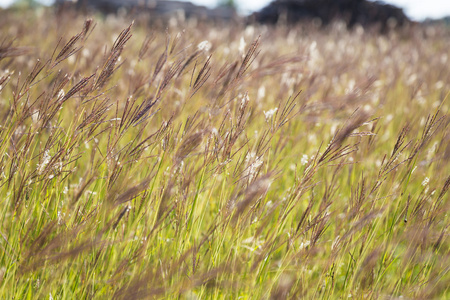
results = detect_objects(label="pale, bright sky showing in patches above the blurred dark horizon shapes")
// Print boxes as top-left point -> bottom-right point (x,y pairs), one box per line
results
0,0 -> 450,21
